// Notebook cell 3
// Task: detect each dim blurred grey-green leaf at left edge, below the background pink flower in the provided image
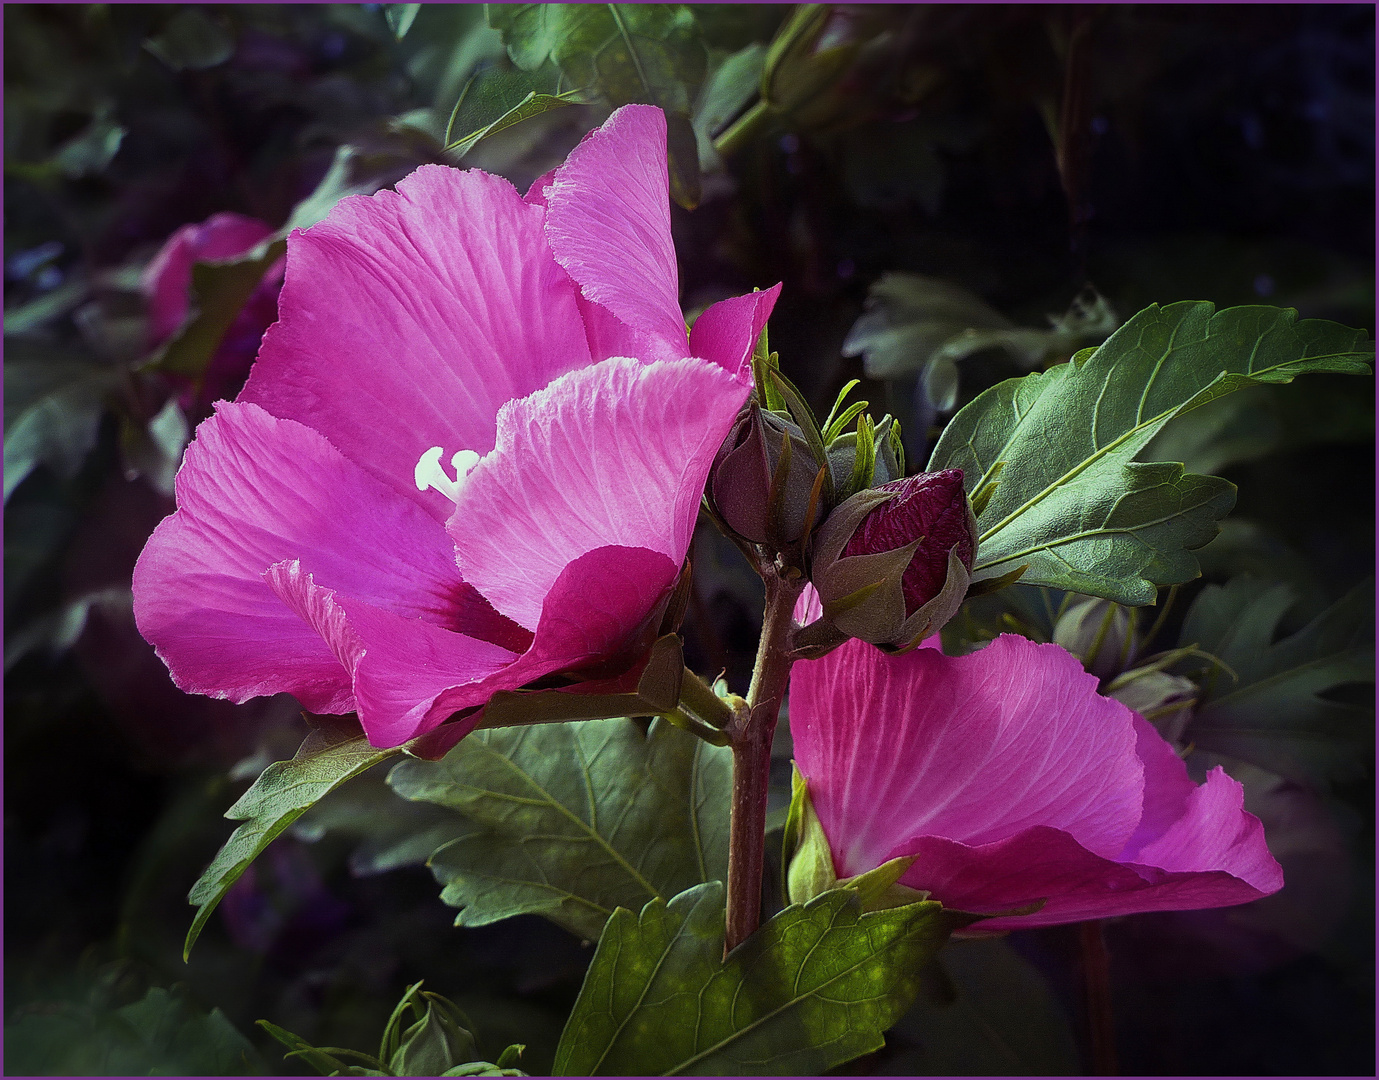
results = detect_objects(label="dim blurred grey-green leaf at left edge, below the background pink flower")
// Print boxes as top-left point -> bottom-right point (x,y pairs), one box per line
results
4,338 -> 119,501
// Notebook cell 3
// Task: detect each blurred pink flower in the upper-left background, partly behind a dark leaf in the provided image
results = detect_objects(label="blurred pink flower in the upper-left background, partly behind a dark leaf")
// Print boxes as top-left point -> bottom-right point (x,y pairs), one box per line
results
141,212 -> 284,403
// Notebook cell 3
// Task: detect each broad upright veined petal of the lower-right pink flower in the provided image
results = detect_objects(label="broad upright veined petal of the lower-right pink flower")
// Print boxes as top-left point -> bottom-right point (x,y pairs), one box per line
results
790,634 -> 1143,874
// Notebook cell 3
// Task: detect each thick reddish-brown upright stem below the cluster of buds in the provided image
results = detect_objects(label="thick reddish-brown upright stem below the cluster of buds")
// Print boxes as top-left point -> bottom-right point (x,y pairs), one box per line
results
724,571 -> 804,952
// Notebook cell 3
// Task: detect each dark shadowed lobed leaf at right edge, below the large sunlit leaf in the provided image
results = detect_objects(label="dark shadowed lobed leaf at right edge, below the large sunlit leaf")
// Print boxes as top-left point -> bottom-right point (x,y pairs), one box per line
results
1180,577 -> 1373,785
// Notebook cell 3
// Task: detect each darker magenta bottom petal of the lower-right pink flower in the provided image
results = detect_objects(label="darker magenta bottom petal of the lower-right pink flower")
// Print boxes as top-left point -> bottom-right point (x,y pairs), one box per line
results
895,826 -> 1273,931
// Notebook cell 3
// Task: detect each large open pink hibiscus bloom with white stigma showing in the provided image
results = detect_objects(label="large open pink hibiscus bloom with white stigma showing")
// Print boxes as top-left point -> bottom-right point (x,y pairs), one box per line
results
134,106 -> 778,746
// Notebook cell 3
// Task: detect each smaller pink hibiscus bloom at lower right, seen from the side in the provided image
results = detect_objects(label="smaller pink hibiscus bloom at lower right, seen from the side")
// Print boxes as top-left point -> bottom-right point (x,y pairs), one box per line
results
790,634 -> 1282,930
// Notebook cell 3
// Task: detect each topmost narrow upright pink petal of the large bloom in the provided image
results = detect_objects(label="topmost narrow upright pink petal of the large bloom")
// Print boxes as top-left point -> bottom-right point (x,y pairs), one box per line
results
540,105 -> 690,360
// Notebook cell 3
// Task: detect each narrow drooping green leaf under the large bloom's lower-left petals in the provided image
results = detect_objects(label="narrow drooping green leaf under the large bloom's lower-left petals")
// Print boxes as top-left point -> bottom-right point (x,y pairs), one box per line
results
182,727 -> 403,959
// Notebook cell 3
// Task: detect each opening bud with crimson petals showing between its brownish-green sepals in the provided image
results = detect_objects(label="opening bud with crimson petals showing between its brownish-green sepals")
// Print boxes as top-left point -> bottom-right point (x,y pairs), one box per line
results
812,469 -> 976,647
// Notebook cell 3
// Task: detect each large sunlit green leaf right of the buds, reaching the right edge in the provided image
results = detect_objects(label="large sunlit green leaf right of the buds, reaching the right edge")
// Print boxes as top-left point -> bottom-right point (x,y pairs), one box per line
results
928,302 -> 1373,604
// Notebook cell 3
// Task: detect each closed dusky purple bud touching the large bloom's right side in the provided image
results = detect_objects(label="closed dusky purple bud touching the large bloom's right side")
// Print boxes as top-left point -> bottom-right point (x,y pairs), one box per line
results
709,406 -> 819,548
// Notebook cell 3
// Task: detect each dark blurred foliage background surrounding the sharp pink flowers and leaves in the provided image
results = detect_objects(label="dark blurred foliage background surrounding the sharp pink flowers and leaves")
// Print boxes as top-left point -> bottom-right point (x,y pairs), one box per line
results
4,4 -> 1375,1074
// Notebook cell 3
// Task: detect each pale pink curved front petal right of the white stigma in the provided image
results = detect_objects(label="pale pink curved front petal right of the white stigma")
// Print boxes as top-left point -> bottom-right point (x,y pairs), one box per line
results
447,359 -> 749,629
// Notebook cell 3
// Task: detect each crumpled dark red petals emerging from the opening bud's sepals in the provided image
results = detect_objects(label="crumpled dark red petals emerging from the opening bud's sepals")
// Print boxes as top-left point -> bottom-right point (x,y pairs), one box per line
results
843,469 -> 976,617
